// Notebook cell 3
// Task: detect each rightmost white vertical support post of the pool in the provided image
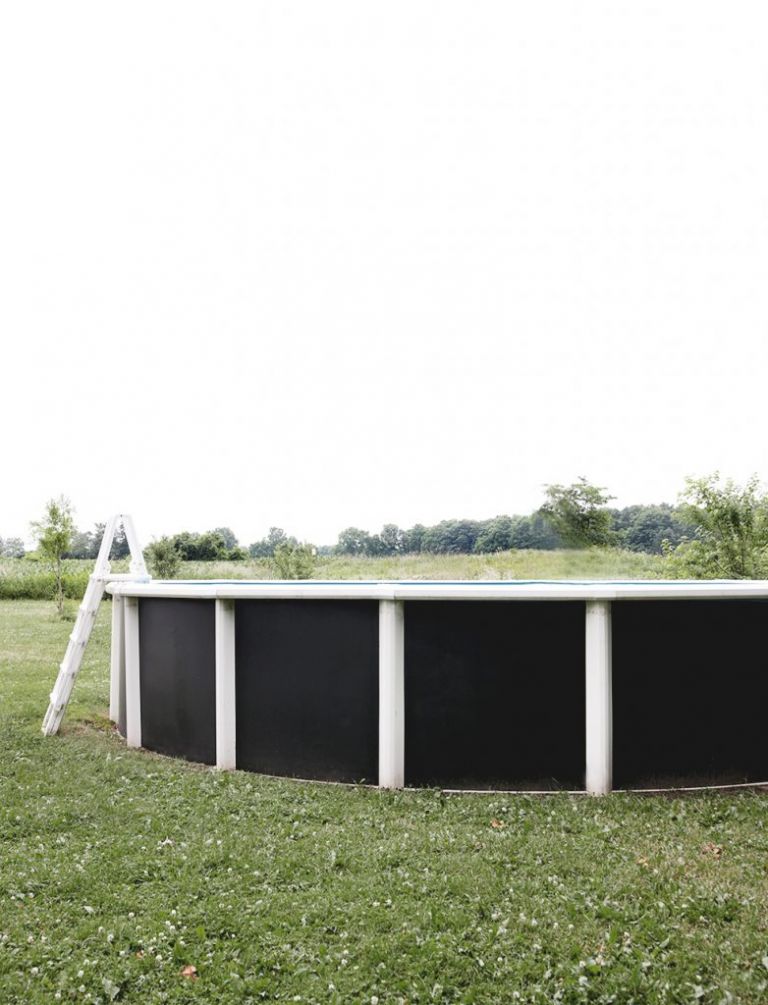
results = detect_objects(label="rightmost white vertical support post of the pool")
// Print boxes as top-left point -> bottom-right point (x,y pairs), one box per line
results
586,600 -> 613,796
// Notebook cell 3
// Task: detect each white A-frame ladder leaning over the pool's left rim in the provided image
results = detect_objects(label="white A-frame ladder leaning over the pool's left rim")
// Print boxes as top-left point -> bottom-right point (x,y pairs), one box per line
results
42,513 -> 150,737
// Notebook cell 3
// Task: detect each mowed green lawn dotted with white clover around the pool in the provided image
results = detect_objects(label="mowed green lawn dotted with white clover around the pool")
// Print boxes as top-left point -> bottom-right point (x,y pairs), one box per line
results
0,601 -> 768,1005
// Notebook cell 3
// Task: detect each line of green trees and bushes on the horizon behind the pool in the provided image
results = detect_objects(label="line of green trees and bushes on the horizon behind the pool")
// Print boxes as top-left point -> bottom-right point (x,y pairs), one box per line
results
16,472 -> 768,605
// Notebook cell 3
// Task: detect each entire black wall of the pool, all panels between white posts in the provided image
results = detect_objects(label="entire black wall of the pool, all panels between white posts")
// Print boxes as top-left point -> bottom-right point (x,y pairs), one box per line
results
131,586 -> 768,789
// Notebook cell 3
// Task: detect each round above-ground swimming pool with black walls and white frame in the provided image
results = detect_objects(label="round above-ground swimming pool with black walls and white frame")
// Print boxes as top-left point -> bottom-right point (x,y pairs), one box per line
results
109,581 -> 768,794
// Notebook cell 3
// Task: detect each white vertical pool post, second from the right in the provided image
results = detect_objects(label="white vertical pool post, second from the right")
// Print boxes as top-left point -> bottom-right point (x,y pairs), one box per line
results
379,600 -> 405,789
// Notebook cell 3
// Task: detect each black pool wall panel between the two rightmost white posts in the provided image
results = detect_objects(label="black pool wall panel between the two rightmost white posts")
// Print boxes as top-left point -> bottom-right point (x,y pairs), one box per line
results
405,601 -> 585,789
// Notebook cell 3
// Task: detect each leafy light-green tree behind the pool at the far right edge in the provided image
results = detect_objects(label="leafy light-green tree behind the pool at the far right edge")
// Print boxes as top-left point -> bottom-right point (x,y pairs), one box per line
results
666,471 -> 768,579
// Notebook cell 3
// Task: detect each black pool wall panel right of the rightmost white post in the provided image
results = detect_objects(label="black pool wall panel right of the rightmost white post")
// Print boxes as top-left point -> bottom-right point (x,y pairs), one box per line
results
613,600 -> 768,788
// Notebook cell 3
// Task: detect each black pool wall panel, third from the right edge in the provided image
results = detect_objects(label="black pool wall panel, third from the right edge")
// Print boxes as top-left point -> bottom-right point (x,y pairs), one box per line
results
235,600 -> 379,784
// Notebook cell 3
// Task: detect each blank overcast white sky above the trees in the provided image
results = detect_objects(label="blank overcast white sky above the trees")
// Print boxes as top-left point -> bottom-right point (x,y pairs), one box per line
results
0,0 -> 768,543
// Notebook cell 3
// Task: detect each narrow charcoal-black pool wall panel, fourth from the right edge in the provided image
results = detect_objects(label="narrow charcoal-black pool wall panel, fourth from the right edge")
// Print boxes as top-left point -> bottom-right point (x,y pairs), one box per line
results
139,598 -> 216,764
